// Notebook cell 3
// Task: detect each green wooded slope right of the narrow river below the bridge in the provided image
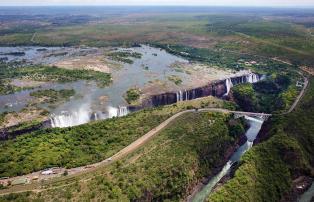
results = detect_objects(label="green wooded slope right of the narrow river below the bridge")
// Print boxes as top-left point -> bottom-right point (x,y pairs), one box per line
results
208,78 -> 314,201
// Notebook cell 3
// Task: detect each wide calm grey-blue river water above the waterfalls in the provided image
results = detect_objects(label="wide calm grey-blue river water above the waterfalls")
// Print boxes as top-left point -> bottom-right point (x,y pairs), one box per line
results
0,45 -> 188,118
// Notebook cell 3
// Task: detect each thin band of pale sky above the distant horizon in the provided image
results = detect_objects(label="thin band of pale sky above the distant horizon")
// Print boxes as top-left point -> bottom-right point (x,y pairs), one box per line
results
0,0 -> 314,8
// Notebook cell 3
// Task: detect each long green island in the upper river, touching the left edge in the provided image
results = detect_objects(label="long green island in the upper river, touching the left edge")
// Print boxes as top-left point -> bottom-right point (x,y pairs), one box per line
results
0,64 -> 111,86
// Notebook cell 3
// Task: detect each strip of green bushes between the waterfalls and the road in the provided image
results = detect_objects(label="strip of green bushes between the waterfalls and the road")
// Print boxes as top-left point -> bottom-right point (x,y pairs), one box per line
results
0,98 -> 231,177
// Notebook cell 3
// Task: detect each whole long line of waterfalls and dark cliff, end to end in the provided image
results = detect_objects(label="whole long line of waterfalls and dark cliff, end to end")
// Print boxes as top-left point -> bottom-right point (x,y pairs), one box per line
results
50,72 -> 264,128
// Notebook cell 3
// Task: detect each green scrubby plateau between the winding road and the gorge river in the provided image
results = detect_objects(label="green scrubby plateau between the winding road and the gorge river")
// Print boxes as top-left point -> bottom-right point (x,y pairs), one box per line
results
2,113 -> 243,201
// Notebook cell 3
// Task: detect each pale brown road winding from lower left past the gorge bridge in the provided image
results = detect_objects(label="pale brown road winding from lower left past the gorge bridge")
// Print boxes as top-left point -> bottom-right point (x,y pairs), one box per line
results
0,77 -> 308,195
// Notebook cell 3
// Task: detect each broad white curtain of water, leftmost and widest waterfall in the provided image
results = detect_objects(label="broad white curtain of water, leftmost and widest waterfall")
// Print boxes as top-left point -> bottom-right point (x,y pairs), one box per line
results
50,107 -> 90,128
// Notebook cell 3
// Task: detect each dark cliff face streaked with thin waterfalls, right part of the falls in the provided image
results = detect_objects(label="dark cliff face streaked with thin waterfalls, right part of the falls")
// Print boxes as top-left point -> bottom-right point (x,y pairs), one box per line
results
142,73 -> 262,107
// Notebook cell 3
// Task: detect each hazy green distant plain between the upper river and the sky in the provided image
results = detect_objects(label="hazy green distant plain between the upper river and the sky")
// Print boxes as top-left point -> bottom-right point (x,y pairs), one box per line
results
0,9 -> 314,66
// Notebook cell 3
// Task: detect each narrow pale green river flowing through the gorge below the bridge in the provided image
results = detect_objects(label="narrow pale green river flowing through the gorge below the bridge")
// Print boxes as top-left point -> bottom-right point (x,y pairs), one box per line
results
192,116 -> 263,202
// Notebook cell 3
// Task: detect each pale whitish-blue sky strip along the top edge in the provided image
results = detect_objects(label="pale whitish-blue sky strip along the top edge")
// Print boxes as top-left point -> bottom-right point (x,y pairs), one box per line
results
0,0 -> 314,7
